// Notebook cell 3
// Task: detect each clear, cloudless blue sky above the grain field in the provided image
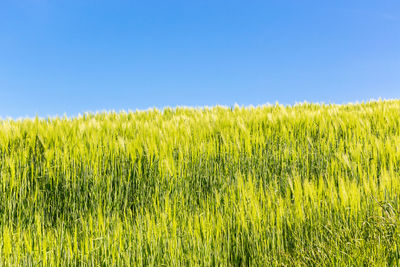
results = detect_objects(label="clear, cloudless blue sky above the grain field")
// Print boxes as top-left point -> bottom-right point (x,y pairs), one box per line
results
0,0 -> 400,118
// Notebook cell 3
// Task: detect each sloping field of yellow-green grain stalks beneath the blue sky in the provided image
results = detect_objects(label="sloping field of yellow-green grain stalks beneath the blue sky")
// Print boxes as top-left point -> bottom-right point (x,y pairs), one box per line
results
0,100 -> 400,266
